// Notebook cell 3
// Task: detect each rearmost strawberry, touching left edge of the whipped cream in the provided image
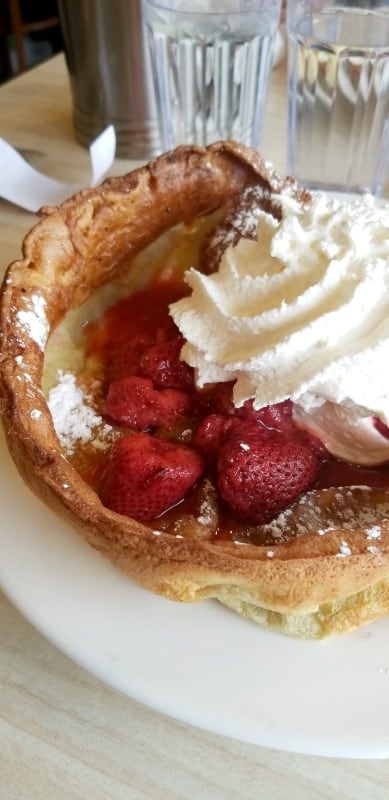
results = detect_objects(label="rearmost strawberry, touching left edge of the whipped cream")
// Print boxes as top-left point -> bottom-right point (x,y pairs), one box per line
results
140,336 -> 194,389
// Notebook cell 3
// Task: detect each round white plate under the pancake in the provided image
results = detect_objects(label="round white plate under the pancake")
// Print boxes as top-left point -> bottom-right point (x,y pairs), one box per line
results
0,428 -> 389,758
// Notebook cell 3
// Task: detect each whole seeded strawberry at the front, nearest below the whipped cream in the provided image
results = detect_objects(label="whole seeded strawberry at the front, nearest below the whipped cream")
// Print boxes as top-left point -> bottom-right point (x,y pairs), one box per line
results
217,421 -> 320,524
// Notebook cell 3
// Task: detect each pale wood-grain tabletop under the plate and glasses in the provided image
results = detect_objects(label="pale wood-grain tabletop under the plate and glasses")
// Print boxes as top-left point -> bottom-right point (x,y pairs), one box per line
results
0,55 -> 389,800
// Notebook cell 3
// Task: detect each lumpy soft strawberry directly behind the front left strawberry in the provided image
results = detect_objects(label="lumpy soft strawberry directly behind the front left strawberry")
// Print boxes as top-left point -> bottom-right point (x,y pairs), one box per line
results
103,376 -> 190,431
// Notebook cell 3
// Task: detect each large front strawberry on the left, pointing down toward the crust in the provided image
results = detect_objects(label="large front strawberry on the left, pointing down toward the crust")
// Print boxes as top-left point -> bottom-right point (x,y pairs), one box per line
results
100,433 -> 203,522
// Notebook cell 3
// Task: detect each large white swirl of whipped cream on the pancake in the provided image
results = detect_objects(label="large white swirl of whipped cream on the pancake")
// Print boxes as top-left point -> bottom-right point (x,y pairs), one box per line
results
171,194 -> 389,463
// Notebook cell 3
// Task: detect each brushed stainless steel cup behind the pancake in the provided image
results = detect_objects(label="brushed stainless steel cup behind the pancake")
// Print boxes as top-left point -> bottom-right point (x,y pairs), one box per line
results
58,0 -> 160,159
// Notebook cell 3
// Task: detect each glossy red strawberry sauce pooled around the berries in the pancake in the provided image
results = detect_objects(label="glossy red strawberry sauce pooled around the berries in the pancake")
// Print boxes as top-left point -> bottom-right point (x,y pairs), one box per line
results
77,279 -> 389,539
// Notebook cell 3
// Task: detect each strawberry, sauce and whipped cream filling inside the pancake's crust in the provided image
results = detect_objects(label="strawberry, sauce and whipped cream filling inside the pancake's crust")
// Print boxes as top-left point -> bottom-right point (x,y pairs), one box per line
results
48,195 -> 389,558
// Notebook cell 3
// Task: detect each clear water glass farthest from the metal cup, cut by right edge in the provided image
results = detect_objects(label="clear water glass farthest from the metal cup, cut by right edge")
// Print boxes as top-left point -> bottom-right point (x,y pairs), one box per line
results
287,0 -> 389,196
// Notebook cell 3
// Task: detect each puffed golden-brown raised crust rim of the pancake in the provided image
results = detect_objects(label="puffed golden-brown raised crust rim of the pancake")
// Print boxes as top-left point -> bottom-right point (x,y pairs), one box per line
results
0,142 -> 389,637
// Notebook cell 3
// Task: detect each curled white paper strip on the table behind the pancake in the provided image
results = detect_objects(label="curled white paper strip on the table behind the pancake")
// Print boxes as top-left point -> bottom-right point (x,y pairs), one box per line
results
0,125 -> 116,212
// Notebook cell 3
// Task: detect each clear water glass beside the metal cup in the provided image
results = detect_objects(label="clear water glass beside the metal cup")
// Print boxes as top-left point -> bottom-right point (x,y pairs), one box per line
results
143,0 -> 281,150
